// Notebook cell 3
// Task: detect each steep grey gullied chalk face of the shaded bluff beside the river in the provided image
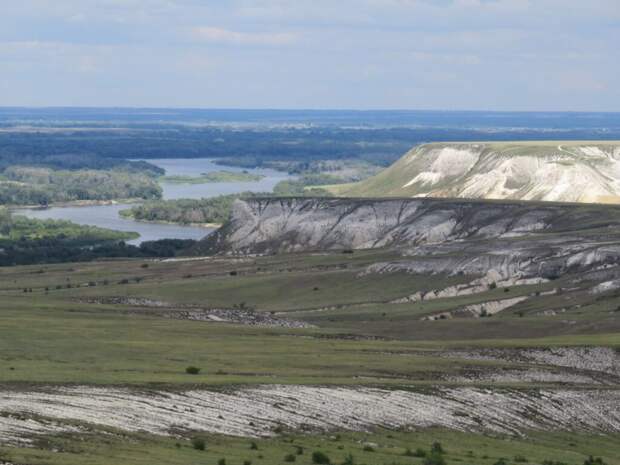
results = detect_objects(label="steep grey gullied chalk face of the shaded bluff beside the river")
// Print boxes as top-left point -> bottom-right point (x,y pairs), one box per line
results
199,197 -> 620,254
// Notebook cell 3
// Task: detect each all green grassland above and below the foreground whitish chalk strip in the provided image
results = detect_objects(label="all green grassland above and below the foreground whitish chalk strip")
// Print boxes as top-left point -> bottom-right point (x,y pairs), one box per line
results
0,250 -> 620,465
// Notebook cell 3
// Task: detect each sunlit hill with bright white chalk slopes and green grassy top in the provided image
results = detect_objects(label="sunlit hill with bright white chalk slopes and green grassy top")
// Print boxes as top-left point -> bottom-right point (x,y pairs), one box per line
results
328,141 -> 620,203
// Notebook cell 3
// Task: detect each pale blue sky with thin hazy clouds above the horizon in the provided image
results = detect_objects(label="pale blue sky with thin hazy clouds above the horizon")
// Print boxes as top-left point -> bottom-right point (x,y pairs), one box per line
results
0,0 -> 620,111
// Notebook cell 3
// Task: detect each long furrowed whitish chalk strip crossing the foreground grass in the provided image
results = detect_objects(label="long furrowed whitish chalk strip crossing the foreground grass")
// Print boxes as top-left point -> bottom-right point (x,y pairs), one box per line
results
0,385 -> 620,443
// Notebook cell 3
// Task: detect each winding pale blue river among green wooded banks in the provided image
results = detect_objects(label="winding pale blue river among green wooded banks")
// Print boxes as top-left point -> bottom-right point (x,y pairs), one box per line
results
14,158 -> 291,245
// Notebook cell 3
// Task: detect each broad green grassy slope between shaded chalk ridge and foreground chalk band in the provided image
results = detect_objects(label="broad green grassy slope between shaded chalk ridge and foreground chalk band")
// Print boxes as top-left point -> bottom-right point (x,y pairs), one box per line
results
0,251 -> 620,385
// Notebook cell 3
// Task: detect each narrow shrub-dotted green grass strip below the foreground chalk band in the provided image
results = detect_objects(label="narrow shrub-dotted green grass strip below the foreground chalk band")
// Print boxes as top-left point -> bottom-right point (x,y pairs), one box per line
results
0,429 -> 620,465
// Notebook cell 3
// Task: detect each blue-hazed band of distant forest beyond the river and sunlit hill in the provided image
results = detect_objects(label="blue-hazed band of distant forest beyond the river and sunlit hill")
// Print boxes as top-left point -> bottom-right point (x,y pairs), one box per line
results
0,124 -> 620,169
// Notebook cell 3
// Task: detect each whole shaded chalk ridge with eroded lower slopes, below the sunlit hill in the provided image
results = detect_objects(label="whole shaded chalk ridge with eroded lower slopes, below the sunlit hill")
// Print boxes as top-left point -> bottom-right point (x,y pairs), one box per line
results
197,197 -> 620,313
